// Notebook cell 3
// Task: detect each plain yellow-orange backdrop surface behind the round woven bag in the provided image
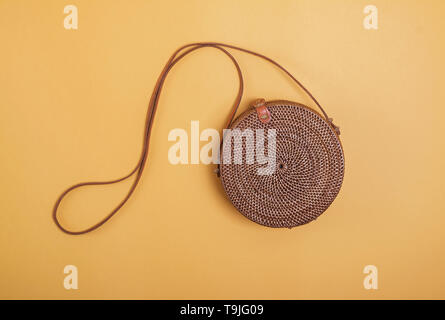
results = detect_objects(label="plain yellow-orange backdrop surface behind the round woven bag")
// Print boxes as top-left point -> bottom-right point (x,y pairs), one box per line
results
0,0 -> 445,299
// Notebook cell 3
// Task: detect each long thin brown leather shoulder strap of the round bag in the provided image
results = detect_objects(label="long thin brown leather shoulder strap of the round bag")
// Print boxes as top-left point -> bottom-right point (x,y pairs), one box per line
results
52,42 -> 337,235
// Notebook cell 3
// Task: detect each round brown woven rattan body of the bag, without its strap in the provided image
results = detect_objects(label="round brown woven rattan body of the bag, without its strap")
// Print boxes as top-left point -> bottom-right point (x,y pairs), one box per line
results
219,101 -> 344,228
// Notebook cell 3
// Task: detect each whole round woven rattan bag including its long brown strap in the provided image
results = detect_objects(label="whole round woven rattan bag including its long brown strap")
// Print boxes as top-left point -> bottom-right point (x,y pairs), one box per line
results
52,42 -> 344,235
